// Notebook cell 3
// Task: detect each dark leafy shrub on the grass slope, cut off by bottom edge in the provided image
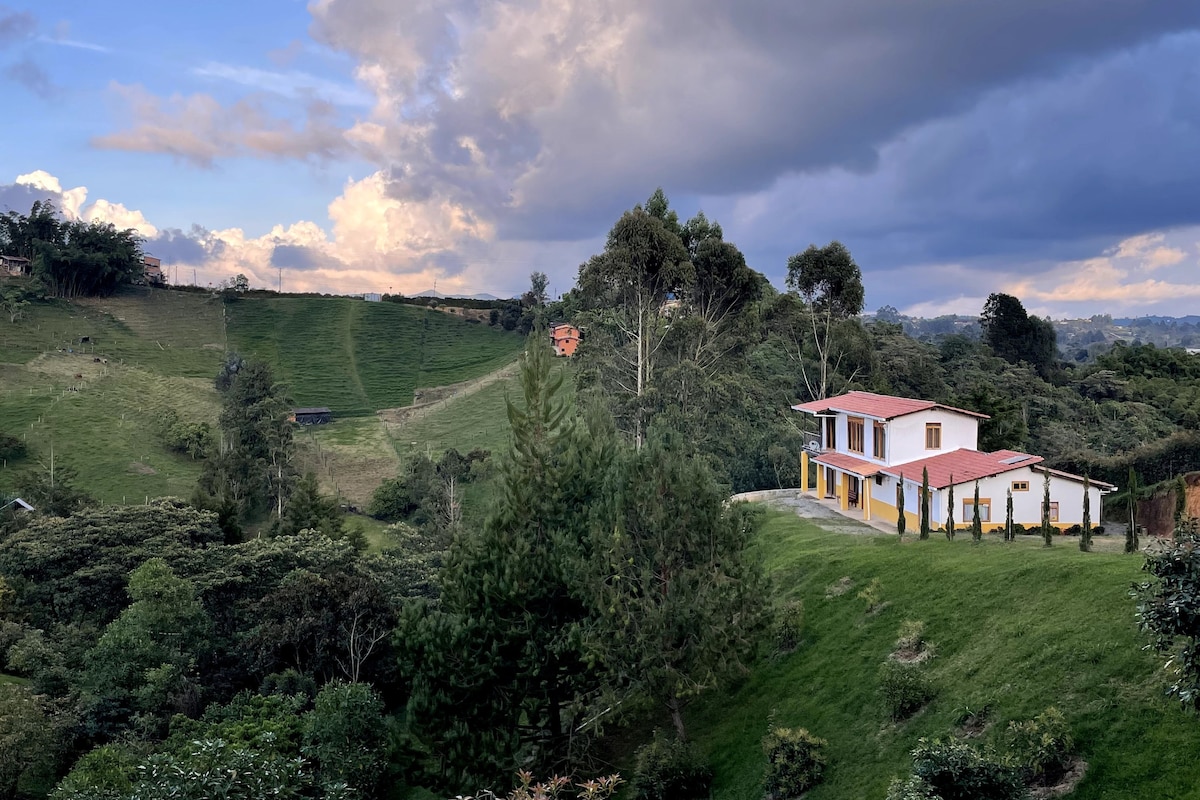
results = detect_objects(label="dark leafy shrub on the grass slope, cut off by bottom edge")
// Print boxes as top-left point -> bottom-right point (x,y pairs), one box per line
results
907,739 -> 1026,800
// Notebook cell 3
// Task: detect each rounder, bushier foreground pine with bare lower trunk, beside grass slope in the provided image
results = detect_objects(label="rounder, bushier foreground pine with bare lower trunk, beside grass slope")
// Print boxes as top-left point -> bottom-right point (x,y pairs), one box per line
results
589,434 -> 766,740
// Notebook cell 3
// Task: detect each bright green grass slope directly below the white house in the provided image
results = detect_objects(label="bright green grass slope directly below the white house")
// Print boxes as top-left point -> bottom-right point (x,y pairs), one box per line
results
688,512 -> 1200,800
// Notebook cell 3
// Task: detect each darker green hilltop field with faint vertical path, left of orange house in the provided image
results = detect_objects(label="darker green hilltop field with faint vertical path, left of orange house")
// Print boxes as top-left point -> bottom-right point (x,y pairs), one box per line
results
227,297 -> 522,416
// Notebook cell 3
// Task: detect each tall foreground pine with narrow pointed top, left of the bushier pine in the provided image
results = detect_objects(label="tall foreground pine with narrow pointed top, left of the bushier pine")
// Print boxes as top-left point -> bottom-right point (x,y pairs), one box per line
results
398,332 -> 614,788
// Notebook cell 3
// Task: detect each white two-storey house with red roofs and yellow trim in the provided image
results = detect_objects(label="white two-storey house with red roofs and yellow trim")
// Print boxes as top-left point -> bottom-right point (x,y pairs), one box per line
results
792,392 -> 1116,530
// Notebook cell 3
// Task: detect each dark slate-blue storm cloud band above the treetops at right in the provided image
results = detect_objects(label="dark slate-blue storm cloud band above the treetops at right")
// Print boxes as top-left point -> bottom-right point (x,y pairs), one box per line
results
710,28 -> 1200,307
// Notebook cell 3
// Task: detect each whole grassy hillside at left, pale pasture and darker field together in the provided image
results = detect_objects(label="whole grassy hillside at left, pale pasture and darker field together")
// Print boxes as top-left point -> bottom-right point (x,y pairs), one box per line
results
0,289 -> 522,503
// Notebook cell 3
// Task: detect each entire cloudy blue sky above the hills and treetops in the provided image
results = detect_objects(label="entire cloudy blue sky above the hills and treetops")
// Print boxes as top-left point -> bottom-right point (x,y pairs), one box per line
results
0,0 -> 1200,317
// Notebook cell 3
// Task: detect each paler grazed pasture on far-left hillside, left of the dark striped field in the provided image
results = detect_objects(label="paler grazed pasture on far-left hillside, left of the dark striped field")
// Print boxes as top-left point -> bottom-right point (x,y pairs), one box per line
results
0,286 -> 224,503
